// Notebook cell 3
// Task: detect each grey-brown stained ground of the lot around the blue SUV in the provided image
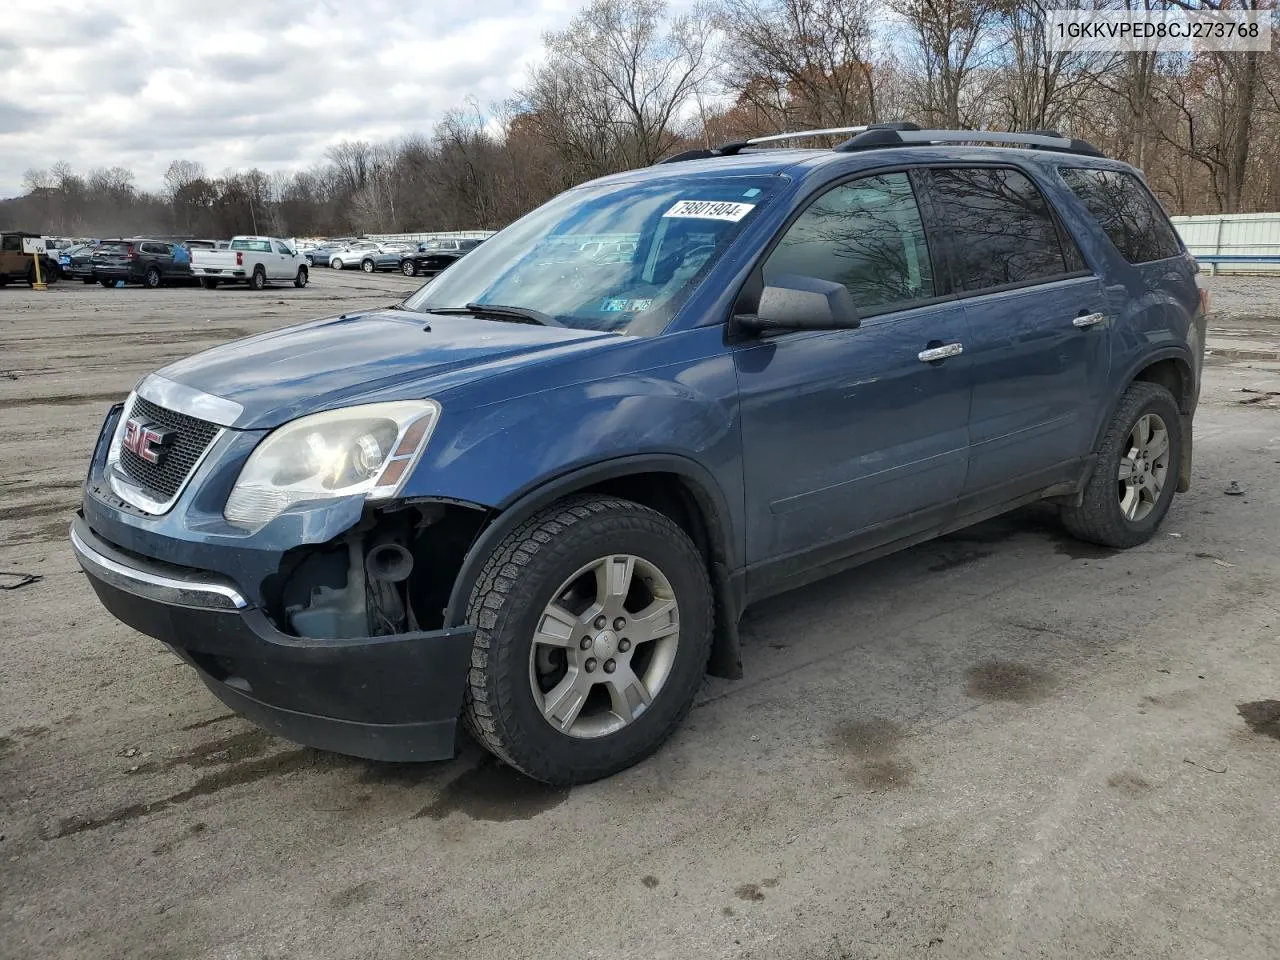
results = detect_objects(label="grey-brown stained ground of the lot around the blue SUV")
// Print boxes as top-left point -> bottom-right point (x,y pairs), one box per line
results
0,270 -> 1280,960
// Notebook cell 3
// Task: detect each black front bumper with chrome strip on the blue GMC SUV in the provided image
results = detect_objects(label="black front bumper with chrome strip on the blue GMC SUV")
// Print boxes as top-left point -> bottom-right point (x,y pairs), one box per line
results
70,517 -> 475,760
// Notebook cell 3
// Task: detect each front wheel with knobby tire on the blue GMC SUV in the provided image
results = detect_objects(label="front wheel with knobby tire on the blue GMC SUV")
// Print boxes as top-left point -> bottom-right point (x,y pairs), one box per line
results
463,497 -> 714,785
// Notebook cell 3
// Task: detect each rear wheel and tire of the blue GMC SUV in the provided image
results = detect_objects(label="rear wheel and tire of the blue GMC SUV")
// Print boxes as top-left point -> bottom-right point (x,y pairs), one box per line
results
1062,380 -> 1183,548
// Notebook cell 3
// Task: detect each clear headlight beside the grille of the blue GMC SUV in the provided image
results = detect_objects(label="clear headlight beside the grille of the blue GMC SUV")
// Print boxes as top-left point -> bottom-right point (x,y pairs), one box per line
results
223,401 -> 440,526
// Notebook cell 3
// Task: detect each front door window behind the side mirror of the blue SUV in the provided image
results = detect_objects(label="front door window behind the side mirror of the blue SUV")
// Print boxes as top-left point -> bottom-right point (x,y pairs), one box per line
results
764,173 -> 934,314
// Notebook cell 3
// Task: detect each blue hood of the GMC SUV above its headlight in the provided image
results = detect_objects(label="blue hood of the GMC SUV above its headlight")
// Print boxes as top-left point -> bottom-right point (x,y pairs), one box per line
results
156,310 -> 616,428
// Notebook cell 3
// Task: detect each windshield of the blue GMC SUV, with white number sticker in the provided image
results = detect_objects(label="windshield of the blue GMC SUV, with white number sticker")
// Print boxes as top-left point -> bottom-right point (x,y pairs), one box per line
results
404,177 -> 778,337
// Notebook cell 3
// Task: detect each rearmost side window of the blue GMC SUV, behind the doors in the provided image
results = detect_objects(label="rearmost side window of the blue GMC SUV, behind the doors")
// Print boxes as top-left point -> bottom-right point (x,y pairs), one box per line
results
1060,166 -> 1183,264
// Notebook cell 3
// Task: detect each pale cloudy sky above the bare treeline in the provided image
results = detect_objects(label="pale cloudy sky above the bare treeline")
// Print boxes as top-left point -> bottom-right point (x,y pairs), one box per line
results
0,0 -> 591,197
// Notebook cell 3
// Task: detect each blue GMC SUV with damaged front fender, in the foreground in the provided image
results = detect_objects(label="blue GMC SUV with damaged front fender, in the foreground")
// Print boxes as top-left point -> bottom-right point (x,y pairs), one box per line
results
70,124 -> 1204,783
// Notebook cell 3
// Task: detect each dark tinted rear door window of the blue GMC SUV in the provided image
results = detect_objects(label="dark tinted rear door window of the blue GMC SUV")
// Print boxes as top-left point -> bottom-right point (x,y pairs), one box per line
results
929,166 -> 1083,292
